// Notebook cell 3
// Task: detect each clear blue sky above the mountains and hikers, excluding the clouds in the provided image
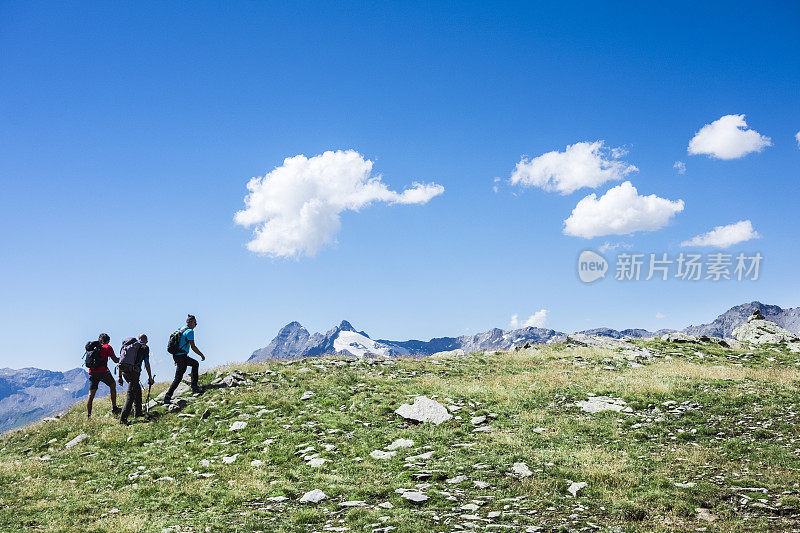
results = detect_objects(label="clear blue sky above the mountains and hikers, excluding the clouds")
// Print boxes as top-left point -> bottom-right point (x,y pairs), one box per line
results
0,1 -> 800,378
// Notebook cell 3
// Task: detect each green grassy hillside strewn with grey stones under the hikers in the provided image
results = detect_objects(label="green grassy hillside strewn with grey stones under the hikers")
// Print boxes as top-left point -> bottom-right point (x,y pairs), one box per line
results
0,342 -> 800,532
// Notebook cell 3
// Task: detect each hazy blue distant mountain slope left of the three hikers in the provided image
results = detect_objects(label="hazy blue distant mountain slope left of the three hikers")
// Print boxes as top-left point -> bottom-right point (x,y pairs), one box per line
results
0,368 -> 95,432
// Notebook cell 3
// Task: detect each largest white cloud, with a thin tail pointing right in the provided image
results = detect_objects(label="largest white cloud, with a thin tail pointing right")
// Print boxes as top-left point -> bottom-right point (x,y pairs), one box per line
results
234,150 -> 444,257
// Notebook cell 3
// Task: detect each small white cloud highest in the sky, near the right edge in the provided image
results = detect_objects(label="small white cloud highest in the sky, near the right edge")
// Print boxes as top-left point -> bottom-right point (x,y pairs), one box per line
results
687,115 -> 772,159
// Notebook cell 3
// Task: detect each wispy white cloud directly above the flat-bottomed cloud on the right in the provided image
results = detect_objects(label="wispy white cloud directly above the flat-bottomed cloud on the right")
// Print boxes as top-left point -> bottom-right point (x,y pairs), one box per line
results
510,141 -> 639,194
